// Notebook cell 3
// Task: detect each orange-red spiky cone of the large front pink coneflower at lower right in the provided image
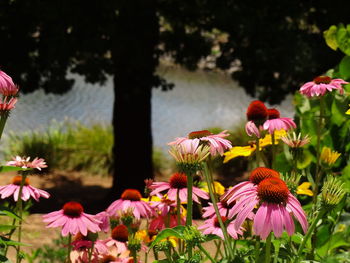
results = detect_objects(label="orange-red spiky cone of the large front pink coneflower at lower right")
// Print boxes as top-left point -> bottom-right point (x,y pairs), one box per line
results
258,178 -> 289,204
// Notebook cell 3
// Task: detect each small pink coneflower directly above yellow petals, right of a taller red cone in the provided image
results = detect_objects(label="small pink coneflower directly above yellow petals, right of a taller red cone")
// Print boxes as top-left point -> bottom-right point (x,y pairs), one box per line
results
263,109 -> 297,134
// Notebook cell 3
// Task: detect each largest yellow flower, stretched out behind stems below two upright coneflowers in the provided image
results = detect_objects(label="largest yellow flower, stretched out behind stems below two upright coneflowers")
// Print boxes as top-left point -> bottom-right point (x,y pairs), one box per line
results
224,129 -> 287,163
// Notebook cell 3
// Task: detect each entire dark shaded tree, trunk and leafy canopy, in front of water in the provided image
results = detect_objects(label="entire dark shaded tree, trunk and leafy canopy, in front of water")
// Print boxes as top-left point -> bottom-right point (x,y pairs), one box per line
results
0,0 -> 350,199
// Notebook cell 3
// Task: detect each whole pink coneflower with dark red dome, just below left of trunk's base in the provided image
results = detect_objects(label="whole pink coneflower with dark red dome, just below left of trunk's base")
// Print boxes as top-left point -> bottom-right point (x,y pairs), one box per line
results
43,202 -> 101,236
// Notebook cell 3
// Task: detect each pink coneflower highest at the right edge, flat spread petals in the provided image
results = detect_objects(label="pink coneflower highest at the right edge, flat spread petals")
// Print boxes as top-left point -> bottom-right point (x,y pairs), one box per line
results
299,76 -> 349,98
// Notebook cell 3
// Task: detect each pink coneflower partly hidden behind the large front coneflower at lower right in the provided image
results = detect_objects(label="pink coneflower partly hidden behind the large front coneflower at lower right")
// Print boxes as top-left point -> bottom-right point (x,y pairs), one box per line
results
221,167 -> 280,206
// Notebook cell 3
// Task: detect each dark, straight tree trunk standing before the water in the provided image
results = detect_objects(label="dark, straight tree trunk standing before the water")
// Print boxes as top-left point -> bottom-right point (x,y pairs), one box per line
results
110,0 -> 159,200
